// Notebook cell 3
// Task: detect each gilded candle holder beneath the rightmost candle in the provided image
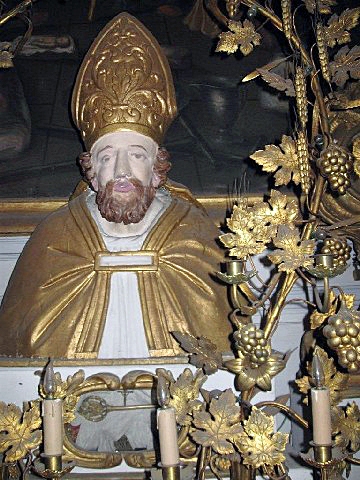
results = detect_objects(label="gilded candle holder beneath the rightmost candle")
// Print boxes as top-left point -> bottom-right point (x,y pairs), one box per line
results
300,442 -> 349,480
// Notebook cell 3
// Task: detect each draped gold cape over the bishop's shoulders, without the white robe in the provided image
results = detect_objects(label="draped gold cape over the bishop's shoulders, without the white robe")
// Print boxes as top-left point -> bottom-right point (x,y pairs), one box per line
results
0,189 -> 231,358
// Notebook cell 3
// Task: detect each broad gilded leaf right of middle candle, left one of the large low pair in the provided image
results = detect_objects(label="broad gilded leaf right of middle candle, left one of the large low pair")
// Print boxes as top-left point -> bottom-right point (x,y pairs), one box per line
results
191,389 -> 242,454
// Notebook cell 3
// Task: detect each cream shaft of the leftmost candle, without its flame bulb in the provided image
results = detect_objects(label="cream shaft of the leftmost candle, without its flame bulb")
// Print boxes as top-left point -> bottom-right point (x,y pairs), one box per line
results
42,398 -> 63,455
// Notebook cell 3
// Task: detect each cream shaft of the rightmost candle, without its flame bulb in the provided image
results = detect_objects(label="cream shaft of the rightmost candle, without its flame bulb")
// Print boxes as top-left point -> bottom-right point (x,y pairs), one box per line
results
311,387 -> 331,445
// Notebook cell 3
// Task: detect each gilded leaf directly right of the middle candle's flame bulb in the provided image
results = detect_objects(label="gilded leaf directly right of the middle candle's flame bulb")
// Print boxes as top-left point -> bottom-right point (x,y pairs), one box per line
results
169,368 -> 207,425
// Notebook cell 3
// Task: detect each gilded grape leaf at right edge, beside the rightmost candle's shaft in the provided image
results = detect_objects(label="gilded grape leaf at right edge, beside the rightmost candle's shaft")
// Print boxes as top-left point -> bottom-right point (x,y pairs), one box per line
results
331,402 -> 360,452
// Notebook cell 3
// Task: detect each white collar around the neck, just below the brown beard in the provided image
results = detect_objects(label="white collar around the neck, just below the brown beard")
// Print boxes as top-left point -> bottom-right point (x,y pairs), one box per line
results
96,196 -> 163,237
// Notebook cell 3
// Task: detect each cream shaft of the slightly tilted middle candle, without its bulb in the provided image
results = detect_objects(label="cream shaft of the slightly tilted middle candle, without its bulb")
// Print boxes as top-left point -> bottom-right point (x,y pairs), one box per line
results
157,407 -> 179,467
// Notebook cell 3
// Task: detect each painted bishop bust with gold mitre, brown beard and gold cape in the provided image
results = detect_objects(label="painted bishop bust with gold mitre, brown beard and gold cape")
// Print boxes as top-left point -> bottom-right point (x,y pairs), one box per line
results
0,13 -> 231,358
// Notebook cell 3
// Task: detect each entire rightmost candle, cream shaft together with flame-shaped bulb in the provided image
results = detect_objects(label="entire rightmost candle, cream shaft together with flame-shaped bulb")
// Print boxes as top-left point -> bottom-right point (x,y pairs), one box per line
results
311,354 -> 331,445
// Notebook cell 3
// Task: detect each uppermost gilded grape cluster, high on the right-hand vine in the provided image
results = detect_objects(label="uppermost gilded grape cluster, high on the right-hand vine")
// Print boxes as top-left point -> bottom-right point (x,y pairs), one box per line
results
319,143 -> 354,195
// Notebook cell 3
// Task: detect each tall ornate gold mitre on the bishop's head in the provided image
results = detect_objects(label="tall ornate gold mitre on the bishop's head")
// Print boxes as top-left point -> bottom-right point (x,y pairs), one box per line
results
71,13 -> 177,150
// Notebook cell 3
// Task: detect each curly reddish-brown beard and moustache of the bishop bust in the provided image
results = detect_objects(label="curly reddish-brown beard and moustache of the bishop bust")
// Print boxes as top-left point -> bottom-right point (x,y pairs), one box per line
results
96,178 -> 156,225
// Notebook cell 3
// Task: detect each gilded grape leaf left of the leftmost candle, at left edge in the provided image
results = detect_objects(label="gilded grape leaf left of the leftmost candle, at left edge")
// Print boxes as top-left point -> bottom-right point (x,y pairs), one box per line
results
0,402 -> 42,462
